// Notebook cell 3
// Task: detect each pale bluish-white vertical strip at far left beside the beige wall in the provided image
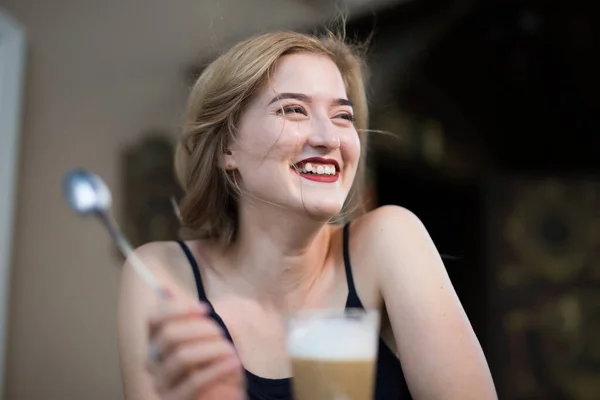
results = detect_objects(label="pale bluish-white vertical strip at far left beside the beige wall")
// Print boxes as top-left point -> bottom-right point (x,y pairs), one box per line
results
0,8 -> 25,395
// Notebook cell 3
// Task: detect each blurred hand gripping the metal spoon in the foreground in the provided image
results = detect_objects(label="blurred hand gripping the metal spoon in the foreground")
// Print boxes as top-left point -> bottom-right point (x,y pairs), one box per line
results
148,299 -> 245,400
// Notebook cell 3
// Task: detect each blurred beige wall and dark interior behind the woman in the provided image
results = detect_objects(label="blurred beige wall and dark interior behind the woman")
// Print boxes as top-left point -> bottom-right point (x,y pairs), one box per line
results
0,0 -> 600,400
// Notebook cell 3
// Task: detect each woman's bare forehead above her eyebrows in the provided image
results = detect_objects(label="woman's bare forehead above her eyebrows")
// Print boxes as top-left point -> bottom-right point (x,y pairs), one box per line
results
266,53 -> 346,98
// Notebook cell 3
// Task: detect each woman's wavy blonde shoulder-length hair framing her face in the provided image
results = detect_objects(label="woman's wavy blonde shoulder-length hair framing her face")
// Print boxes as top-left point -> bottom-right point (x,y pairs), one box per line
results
175,28 -> 368,246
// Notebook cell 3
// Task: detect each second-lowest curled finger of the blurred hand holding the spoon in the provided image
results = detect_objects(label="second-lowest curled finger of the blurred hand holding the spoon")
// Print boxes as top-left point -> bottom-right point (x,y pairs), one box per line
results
158,340 -> 237,387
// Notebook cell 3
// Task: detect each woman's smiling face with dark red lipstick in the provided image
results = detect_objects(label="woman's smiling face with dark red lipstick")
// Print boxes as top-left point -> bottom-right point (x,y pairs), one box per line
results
231,53 -> 360,219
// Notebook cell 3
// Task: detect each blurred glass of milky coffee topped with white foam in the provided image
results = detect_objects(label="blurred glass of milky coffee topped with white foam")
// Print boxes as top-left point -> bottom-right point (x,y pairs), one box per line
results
287,309 -> 380,400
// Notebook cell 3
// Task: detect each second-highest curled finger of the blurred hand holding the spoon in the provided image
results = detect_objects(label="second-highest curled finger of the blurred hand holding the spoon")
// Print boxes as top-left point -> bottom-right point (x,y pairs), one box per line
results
150,318 -> 224,358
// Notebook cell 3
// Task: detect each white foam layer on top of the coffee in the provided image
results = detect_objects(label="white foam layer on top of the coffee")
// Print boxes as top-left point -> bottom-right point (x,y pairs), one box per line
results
287,320 -> 377,360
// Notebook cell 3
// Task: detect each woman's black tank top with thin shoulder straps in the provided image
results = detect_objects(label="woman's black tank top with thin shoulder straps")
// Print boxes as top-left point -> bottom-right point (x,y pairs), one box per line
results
178,224 -> 412,400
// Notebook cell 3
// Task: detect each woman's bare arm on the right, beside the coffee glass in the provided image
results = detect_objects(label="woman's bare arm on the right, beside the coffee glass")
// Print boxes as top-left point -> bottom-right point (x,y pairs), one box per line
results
368,206 -> 497,400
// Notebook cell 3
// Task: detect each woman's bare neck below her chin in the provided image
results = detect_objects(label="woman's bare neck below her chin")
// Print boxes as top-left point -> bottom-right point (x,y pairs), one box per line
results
230,204 -> 331,311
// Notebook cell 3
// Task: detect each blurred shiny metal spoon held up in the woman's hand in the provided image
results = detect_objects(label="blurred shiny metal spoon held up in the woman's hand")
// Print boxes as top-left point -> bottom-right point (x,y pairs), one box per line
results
63,169 -> 171,298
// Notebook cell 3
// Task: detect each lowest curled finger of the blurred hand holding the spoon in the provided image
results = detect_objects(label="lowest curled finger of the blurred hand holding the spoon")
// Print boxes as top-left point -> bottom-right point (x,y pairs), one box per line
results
165,357 -> 241,400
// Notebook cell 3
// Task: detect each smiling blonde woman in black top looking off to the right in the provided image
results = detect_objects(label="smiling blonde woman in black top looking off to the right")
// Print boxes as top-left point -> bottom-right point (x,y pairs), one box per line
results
119,28 -> 496,400
